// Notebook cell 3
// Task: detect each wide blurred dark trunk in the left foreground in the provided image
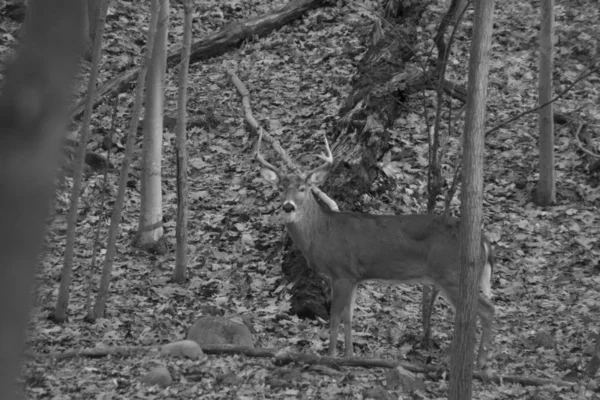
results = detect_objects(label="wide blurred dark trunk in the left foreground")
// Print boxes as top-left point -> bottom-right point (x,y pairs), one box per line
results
0,0 -> 83,394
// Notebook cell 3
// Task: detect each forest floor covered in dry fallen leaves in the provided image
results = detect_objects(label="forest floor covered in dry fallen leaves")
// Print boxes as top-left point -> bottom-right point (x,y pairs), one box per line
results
0,0 -> 600,399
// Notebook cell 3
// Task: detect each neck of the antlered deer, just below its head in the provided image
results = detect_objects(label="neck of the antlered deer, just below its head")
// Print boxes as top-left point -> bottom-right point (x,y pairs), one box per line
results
286,191 -> 329,256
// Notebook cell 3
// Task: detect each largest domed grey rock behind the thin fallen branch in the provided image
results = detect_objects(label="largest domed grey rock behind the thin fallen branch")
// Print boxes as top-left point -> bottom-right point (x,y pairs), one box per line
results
187,316 -> 254,347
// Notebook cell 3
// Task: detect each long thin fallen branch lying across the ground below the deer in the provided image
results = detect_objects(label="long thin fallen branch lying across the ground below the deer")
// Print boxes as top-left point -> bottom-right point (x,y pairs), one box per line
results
43,344 -> 580,387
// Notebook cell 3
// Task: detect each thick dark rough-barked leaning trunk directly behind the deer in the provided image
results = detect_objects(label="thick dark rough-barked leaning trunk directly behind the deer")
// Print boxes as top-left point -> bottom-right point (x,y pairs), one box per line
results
282,2 -> 429,319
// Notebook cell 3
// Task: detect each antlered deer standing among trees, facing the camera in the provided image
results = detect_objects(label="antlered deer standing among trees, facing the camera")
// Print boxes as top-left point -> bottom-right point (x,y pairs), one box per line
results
255,132 -> 494,368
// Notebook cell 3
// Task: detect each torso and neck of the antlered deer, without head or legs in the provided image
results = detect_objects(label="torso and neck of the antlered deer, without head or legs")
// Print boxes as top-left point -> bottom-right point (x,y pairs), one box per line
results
286,196 -> 480,283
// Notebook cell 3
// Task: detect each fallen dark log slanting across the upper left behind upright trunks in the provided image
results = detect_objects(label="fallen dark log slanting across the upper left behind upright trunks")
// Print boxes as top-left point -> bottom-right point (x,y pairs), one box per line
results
71,0 -> 323,119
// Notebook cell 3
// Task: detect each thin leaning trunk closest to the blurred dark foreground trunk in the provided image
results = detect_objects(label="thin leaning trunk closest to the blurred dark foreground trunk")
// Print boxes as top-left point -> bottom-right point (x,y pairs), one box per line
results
54,0 -> 108,323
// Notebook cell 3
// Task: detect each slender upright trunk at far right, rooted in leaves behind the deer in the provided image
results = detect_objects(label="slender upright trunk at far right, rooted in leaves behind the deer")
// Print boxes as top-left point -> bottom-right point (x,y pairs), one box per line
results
535,0 -> 556,206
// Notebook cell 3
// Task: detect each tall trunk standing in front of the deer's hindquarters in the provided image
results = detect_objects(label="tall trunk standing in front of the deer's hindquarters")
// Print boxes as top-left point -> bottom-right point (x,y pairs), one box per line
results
449,0 -> 494,400
